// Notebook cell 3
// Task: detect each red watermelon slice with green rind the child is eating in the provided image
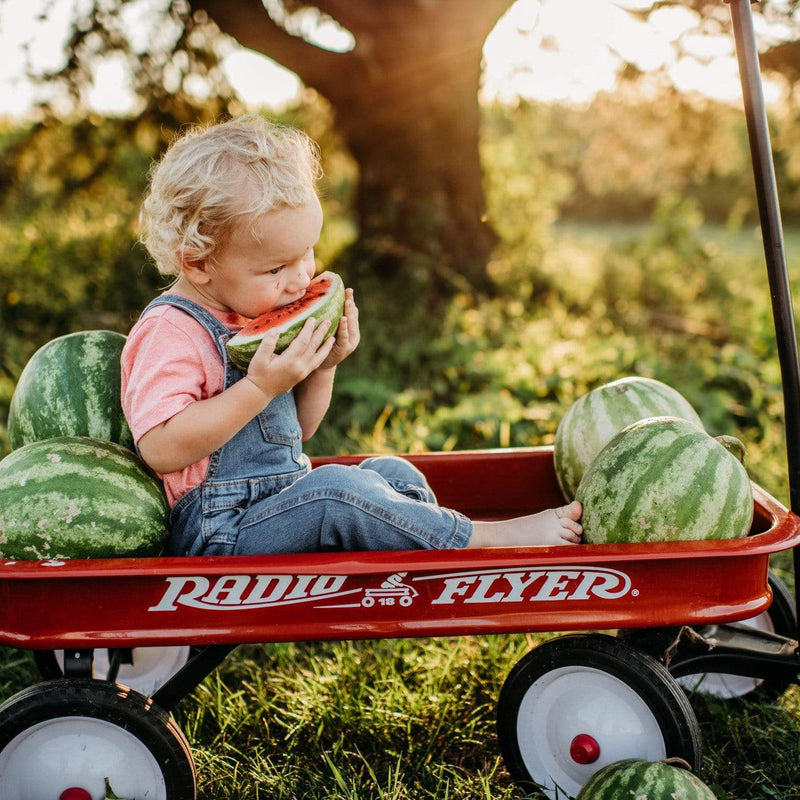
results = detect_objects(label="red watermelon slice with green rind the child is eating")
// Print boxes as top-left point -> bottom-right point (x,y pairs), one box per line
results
226,272 -> 344,371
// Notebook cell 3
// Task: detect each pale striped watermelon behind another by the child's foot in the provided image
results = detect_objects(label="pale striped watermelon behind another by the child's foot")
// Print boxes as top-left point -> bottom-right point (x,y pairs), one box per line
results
554,376 -> 703,500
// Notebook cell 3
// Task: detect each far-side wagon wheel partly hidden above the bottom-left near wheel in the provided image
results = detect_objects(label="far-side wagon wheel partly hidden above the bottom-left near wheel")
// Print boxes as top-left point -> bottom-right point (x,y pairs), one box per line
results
33,645 -> 192,697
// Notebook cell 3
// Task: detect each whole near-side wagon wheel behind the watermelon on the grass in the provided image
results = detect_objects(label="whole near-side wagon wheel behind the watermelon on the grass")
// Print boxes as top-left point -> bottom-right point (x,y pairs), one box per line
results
497,634 -> 700,800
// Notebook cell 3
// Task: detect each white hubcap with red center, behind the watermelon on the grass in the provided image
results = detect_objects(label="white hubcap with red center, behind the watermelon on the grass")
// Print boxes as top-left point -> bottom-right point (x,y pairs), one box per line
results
517,667 -> 666,800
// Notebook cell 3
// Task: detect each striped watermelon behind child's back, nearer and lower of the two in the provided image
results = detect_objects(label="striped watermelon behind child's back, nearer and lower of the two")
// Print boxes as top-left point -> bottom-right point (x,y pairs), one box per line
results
0,436 -> 168,559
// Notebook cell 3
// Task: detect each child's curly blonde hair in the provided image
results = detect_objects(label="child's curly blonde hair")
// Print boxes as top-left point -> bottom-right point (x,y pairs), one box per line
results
139,114 -> 322,276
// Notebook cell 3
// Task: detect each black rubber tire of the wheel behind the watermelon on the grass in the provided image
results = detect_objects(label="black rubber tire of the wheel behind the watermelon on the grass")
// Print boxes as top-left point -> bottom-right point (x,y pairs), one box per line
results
497,634 -> 702,797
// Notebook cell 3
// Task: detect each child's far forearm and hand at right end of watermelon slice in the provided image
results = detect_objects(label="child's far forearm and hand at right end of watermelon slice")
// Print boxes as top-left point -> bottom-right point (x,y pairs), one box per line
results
294,289 -> 361,442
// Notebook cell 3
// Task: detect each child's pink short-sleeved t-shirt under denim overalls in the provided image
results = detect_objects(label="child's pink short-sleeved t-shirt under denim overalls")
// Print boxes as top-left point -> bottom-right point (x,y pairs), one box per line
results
122,294 -> 248,506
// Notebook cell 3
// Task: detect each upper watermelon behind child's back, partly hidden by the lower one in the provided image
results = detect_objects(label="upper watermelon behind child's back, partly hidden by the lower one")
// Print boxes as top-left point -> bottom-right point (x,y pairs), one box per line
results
8,331 -> 133,449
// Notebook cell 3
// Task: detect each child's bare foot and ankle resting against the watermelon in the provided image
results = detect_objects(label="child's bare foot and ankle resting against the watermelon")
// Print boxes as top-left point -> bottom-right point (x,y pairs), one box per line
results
468,500 -> 583,547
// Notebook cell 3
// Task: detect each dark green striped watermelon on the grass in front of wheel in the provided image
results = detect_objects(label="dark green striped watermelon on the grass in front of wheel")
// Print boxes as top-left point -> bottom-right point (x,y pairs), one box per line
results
575,758 -> 717,800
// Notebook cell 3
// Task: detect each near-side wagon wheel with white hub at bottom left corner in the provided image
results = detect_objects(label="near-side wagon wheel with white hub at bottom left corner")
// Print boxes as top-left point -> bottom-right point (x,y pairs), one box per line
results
0,678 -> 196,800
